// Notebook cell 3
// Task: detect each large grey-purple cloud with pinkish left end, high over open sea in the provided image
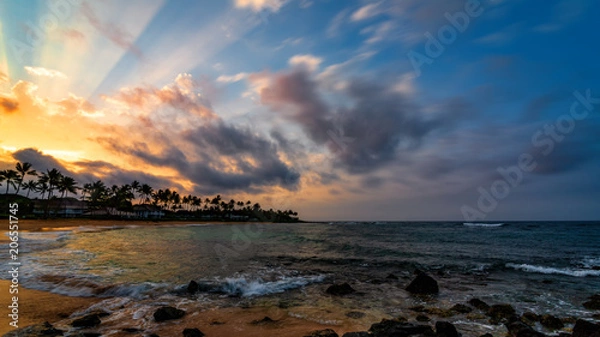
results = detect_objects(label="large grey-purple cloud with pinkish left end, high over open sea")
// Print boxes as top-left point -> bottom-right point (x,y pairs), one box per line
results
255,70 -> 471,173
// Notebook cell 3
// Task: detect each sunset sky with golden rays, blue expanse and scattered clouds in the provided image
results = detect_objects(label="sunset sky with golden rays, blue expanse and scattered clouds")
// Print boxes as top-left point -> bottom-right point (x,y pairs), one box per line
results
0,0 -> 600,222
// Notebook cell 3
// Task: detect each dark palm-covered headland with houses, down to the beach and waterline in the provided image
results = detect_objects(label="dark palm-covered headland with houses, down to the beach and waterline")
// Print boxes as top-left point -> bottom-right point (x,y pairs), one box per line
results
0,163 -> 298,222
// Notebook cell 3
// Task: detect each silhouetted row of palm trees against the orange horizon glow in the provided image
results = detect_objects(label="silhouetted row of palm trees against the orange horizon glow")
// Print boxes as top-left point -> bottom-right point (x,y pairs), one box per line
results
0,162 -> 298,222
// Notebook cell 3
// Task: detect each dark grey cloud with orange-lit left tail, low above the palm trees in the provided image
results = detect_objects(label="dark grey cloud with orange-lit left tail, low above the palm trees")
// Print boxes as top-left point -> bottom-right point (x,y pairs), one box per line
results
100,121 -> 300,194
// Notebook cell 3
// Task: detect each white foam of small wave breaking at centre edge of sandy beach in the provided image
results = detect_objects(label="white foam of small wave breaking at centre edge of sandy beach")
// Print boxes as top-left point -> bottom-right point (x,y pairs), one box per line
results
221,275 -> 325,297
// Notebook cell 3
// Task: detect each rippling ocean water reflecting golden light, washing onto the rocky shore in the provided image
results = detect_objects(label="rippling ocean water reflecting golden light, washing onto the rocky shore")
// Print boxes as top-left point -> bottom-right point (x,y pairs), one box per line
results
0,222 -> 600,336
